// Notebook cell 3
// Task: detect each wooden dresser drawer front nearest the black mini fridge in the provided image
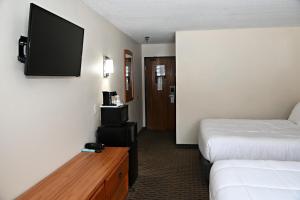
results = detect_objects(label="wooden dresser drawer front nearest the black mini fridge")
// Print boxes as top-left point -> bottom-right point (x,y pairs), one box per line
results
105,155 -> 128,200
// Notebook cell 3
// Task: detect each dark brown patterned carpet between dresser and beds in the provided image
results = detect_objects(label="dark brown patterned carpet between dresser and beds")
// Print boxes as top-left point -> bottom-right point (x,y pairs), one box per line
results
128,131 -> 209,200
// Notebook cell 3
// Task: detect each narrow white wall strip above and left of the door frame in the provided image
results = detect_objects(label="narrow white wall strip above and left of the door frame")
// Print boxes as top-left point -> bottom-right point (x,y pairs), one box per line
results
142,43 -> 176,126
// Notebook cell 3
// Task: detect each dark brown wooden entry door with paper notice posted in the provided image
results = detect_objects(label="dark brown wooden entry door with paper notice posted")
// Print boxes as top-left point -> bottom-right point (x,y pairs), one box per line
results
145,57 -> 176,131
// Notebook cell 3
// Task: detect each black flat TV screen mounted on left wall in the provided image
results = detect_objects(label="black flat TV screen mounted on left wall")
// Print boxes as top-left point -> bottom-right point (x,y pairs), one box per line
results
25,3 -> 84,76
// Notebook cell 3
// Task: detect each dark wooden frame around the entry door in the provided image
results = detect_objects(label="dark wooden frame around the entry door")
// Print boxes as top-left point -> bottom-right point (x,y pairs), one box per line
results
143,56 -> 177,130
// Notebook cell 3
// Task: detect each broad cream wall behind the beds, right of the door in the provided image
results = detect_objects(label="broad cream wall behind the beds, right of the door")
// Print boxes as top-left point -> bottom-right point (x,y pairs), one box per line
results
176,28 -> 300,144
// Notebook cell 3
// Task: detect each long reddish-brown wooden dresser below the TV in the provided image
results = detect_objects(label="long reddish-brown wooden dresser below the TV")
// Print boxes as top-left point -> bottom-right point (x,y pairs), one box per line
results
17,147 -> 128,200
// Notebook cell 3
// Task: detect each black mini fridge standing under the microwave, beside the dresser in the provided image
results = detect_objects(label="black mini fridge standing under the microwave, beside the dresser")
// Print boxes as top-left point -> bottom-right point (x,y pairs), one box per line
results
96,122 -> 138,186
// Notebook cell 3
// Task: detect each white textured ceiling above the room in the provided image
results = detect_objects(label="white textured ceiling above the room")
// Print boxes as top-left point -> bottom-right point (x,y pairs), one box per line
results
83,0 -> 300,43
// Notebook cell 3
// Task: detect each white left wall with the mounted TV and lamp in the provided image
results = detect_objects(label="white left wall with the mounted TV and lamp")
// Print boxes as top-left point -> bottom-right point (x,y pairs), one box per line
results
0,0 -> 142,200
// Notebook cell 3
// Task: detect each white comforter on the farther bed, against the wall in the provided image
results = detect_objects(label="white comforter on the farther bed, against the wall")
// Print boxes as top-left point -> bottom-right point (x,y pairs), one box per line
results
199,119 -> 300,163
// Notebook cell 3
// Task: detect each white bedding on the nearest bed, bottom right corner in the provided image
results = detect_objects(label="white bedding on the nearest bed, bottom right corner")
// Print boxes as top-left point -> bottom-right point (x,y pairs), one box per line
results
210,160 -> 300,200
